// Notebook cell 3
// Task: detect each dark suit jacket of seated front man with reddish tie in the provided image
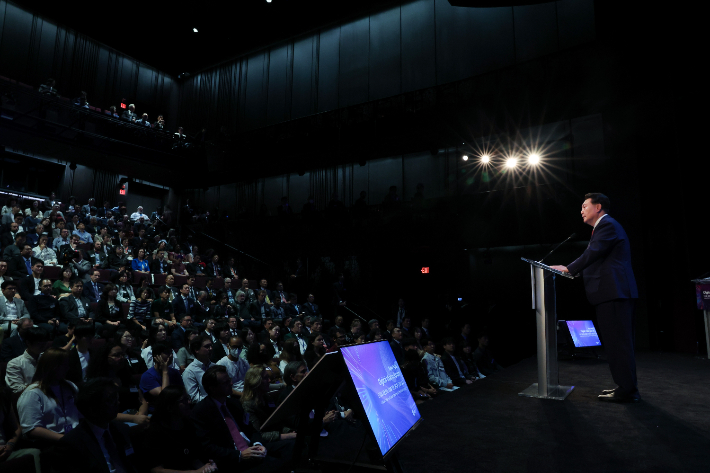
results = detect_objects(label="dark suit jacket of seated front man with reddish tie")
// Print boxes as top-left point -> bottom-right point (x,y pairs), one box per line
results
192,396 -> 262,471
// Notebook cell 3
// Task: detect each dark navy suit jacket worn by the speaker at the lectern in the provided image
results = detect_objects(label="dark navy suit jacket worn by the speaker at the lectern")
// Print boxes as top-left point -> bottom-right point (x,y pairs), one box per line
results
567,215 -> 638,305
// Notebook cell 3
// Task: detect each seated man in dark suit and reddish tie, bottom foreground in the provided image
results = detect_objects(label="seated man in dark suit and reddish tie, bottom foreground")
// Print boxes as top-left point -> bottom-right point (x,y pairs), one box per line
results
192,365 -> 293,471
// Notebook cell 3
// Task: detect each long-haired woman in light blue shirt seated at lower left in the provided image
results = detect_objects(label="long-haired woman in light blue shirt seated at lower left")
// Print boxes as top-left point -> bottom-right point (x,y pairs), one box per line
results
17,348 -> 81,449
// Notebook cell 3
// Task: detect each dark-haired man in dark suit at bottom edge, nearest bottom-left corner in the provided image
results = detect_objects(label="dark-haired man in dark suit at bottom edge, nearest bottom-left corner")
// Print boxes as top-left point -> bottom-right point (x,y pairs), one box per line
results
48,378 -> 137,473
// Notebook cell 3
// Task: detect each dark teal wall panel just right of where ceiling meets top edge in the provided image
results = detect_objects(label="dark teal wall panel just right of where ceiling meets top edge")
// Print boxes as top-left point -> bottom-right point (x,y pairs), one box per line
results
401,0 -> 436,92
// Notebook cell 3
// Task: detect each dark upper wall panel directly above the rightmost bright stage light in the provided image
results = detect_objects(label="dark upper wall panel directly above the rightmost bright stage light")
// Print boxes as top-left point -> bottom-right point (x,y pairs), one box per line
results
513,3 -> 558,62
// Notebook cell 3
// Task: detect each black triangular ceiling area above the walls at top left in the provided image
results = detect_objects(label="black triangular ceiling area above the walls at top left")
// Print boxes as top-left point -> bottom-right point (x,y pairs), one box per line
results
15,0 -> 400,75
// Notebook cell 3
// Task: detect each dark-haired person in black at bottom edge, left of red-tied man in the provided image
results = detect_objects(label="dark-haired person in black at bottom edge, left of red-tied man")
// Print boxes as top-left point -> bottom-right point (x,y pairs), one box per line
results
145,385 -> 217,473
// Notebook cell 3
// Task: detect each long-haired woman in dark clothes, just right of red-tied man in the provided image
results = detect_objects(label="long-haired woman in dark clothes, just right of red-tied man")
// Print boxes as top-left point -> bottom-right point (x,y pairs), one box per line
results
241,365 -> 296,443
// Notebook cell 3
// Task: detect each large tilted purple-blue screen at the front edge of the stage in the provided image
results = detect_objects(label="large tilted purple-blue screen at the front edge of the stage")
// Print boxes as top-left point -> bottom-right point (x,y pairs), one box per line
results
340,341 -> 421,455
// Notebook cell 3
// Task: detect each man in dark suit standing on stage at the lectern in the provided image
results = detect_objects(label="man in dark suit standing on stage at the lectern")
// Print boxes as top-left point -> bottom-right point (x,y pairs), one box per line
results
552,192 -> 641,402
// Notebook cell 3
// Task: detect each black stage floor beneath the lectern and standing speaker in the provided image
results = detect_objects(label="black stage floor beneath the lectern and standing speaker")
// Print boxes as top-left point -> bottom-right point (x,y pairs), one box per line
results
399,351 -> 710,473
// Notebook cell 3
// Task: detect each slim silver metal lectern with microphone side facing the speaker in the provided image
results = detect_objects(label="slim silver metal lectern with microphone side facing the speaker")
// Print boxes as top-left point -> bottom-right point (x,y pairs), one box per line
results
518,258 -> 574,401
